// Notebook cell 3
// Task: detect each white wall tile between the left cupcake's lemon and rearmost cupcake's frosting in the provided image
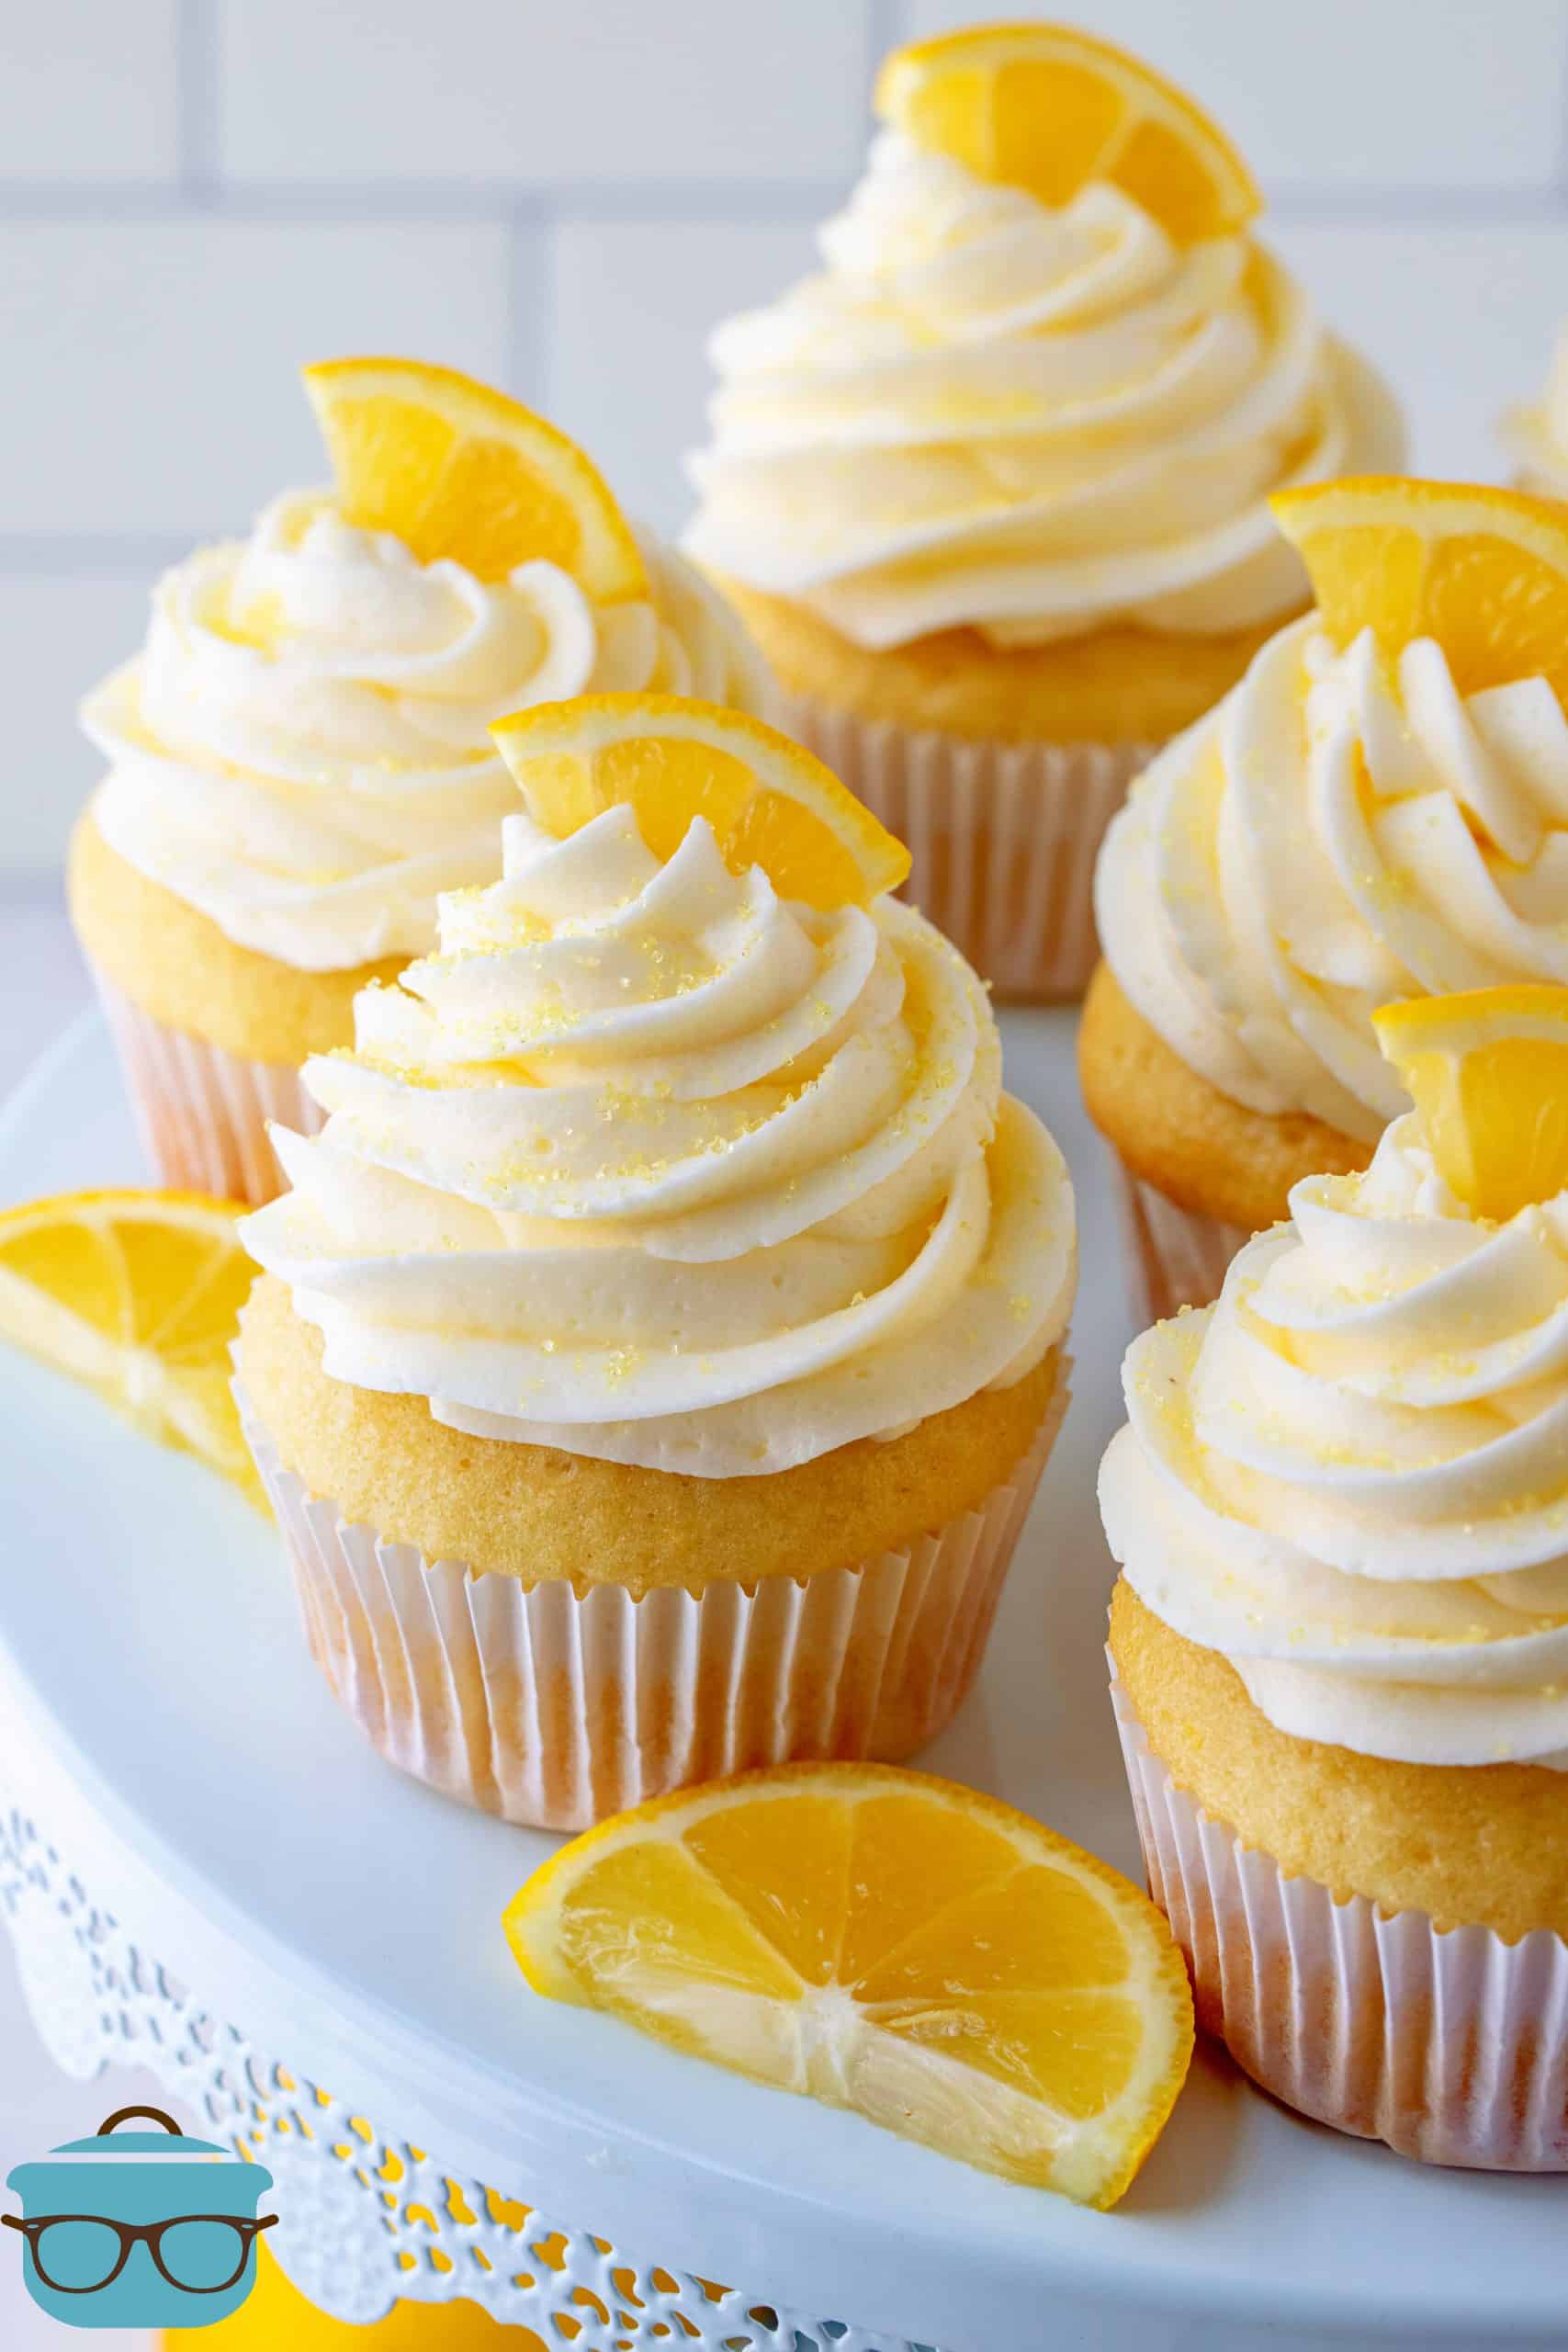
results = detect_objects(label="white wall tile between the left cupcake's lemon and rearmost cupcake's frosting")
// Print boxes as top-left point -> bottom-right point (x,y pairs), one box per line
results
547,219 -> 816,529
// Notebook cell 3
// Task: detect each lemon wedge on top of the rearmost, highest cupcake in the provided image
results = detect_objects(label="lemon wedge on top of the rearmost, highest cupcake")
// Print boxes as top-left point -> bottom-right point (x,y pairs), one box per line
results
874,24 -> 1262,244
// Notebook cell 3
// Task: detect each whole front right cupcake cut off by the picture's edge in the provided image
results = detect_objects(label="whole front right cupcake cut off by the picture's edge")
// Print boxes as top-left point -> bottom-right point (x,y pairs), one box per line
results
1100,988 -> 1568,2171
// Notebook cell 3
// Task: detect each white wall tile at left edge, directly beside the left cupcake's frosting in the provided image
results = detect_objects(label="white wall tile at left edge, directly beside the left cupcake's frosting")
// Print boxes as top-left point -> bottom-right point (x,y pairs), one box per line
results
0,570 -> 152,873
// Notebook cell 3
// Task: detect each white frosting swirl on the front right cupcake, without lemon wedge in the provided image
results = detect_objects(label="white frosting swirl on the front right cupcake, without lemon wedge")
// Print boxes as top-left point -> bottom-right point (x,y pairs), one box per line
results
1100,1114 -> 1568,1771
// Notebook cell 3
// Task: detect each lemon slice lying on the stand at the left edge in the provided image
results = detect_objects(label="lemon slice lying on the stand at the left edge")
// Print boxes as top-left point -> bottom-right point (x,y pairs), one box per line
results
0,1193 -> 261,1500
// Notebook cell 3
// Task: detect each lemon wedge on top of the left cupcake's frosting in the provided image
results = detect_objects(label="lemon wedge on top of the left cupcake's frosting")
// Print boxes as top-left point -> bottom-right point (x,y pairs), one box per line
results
303,360 -> 649,605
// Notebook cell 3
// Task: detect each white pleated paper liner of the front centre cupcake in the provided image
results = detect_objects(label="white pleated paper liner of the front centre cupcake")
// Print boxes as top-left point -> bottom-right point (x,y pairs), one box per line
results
235,1364 -> 1067,1830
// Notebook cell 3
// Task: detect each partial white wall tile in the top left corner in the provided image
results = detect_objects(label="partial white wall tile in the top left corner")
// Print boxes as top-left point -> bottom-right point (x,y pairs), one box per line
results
0,0 -> 179,195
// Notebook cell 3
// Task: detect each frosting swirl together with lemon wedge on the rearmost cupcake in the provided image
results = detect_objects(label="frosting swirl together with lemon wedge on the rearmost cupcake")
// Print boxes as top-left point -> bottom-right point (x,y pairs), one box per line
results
686,26 -> 1401,647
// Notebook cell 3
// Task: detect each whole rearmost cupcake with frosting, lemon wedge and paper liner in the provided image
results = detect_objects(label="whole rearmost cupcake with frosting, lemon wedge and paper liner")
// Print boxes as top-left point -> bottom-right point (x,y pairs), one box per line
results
684,24 -> 1401,1000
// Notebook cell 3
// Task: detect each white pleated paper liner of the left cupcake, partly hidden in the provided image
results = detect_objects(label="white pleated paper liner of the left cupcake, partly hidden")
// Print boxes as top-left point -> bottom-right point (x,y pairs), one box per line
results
92,969 -> 324,1206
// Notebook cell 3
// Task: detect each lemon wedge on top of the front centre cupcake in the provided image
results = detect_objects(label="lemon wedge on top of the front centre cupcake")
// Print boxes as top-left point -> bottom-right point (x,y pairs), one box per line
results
491,694 -> 909,910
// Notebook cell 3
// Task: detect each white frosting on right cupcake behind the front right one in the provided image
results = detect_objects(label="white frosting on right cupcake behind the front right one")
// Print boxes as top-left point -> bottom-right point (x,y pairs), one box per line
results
1096,614 -> 1568,1143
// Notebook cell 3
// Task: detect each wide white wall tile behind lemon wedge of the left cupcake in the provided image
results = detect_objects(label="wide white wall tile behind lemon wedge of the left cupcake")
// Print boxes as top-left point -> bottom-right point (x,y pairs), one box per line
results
0,217 -> 510,537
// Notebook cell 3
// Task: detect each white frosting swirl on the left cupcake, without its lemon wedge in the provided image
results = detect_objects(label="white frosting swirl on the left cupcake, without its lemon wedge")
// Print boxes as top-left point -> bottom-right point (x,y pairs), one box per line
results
83,492 -> 764,971
